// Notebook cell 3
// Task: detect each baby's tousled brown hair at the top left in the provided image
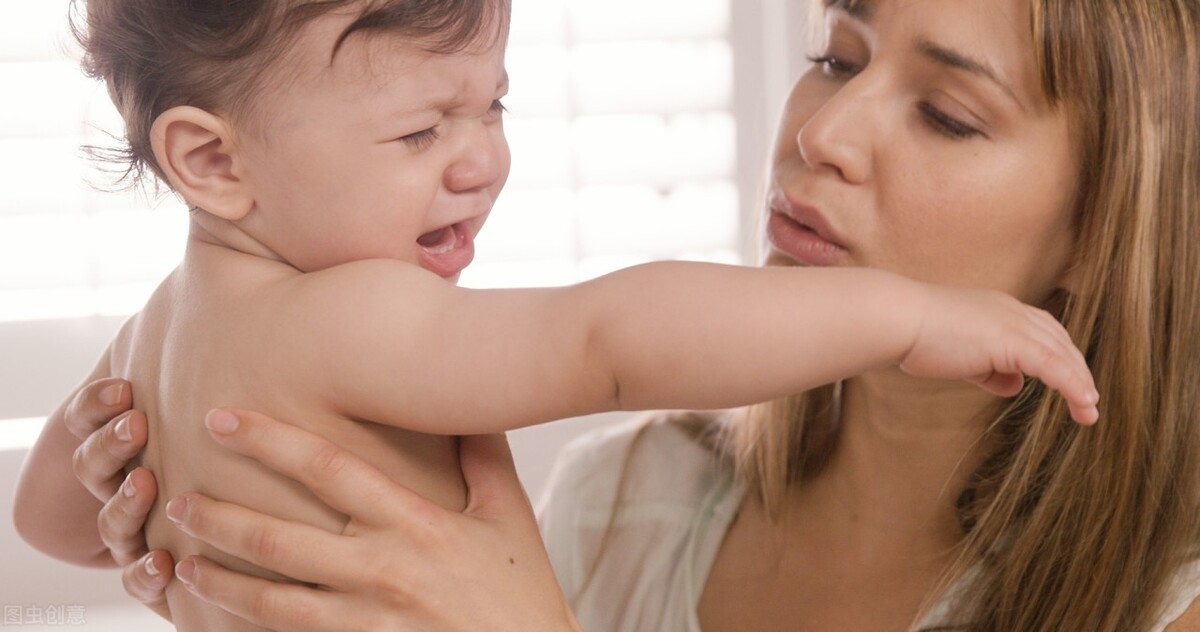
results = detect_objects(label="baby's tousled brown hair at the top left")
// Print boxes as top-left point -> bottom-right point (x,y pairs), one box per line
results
71,0 -> 511,187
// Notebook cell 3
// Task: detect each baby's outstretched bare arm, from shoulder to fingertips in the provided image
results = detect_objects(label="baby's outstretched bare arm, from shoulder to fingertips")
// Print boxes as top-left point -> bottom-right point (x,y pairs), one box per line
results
272,261 -> 1093,434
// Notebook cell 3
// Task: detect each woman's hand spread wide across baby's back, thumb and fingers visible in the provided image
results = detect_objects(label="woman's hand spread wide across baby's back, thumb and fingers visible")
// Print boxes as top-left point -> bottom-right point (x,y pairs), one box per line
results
167,410 -> 578,632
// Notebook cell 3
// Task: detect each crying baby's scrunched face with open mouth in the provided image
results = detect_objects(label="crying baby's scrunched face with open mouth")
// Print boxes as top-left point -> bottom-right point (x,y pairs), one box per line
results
228,8 -> 510,281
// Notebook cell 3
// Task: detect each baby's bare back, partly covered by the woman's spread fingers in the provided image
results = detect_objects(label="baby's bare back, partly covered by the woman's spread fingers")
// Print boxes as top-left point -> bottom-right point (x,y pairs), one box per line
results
112,242 -> 464,631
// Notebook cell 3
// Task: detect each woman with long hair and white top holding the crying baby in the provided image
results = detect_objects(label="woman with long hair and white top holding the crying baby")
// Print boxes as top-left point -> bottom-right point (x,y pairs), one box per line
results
58,0 -> 1200,632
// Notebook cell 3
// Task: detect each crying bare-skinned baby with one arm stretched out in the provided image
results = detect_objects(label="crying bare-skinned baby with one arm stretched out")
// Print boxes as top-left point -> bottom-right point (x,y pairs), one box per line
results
17,0 -> 1096,631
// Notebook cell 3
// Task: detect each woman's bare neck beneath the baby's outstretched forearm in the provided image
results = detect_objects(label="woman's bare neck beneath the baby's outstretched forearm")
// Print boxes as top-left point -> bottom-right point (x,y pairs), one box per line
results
796,369 -> 996,555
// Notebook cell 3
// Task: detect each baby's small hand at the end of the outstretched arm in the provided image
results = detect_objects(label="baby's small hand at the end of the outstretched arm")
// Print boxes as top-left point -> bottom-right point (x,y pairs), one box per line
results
900,285 -> 1100,426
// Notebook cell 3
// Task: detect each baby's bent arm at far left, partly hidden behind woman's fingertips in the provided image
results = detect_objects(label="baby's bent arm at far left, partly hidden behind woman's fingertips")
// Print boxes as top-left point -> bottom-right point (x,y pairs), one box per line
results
13,350 -> 130,566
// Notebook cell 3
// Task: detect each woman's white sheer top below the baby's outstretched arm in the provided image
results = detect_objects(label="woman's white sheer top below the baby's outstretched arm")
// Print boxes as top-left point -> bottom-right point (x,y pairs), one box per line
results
538,420 -> 1200,632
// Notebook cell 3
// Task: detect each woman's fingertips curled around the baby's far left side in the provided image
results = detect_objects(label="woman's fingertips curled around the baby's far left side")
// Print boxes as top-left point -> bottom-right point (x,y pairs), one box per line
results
62,378 -> 173,620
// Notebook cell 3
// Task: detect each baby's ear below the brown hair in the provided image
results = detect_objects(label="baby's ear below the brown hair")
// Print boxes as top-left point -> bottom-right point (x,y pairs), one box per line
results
150,106 -> 254,221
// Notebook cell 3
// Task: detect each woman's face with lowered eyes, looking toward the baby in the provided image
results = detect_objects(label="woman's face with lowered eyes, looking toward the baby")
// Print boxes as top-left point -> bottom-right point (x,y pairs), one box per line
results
767,0 -> 1078,303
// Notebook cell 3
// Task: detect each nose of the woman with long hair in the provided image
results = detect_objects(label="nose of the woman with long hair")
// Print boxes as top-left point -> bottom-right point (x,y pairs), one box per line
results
796,80 -> 880,185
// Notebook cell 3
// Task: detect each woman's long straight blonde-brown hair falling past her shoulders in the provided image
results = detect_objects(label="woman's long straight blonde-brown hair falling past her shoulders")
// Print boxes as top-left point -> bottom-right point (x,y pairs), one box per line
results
721,0 -> 1200,632
